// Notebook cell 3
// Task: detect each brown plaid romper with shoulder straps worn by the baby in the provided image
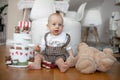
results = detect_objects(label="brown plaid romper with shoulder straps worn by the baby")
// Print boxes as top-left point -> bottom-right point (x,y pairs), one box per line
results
42,33 -> 70,64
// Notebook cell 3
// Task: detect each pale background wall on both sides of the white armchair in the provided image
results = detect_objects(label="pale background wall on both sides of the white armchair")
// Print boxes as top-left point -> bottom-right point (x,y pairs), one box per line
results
7,0 -> 120,42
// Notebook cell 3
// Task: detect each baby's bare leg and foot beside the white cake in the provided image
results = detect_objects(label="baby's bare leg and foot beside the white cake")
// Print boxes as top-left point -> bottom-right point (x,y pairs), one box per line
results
28,54 -> 42,69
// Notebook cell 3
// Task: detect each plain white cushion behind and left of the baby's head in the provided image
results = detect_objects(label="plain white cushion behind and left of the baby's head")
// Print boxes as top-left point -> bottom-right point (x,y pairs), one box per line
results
30,0 -> 55,20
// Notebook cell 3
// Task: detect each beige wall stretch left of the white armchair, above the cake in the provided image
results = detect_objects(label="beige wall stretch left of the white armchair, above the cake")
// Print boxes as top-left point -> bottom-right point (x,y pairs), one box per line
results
7,0 -> 22,40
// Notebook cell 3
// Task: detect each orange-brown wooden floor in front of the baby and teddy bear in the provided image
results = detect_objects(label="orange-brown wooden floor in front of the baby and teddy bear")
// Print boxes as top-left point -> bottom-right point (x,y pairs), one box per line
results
0,46 -> 120,80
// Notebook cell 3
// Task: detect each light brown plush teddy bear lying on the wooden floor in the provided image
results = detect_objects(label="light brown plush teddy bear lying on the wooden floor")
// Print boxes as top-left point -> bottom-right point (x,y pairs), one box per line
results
74,42 -> 117,74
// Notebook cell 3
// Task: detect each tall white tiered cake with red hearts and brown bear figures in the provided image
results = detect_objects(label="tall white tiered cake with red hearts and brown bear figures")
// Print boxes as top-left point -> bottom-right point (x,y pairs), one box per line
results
7,21 -> 34,67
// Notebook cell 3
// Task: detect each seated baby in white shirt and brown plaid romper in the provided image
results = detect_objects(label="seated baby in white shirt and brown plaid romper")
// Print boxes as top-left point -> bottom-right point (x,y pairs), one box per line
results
28,13 -> 73,72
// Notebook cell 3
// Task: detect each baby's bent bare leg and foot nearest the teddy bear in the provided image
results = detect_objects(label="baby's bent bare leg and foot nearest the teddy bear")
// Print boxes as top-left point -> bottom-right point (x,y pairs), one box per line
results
55,58 -> 70,72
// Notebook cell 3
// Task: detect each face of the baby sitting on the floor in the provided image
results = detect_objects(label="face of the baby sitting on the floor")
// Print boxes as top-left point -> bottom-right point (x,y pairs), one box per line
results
47,15 -> 63,35
